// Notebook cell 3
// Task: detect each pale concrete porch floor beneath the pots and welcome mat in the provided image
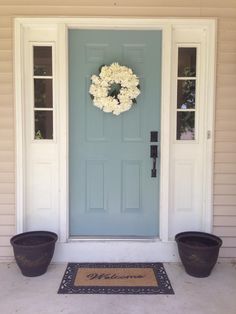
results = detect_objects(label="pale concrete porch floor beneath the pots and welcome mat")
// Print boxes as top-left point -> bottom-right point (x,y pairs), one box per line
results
0,263 -> 236,314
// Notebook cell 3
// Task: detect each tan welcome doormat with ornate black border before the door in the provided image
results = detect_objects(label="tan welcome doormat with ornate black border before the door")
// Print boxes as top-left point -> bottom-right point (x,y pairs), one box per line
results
58,263 -> 174,294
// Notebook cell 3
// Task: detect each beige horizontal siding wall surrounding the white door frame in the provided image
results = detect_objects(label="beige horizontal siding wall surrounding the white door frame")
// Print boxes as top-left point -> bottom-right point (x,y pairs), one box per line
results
0,0 -> 236,258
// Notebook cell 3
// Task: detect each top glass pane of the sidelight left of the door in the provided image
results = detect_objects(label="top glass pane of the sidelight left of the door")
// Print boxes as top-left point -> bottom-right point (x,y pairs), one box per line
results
34,46 -> 52,76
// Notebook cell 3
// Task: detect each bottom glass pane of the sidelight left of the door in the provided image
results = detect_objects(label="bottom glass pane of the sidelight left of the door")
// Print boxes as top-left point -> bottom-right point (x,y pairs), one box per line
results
34,110 -> 53,140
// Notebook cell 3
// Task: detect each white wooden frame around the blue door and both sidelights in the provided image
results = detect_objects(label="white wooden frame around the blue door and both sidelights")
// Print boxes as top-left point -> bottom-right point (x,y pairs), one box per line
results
14,18 -> 216,260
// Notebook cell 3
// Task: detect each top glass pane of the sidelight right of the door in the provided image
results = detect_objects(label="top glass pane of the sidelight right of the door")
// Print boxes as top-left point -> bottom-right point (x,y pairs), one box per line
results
178,48 -> 197,77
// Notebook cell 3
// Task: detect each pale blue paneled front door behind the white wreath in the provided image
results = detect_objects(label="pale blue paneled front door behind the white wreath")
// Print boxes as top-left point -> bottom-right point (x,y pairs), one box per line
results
69,30 -> 162,237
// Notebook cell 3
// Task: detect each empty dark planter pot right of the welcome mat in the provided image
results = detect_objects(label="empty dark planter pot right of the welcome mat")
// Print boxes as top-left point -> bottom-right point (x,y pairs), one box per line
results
175,231 -> 222,277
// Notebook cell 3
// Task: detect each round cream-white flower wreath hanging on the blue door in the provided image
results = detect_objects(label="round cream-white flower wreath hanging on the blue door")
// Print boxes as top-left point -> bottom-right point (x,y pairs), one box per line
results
89,63 -> 140,115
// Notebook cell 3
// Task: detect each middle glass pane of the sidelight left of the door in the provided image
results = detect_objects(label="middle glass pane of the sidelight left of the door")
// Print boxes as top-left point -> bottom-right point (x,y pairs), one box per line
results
34,79 -> 53,108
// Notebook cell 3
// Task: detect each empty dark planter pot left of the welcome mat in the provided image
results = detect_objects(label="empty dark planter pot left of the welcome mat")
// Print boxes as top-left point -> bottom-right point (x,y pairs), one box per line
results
11,231 -> 58,277
